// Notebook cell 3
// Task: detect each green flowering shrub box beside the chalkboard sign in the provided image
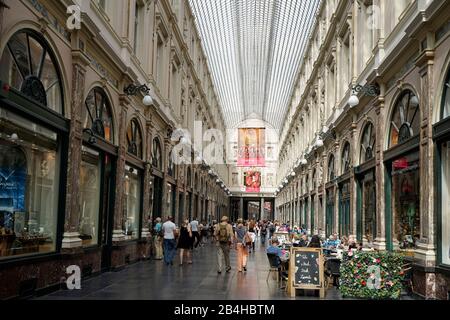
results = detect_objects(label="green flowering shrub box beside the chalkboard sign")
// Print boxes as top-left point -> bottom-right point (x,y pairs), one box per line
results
339,251 -> 405,299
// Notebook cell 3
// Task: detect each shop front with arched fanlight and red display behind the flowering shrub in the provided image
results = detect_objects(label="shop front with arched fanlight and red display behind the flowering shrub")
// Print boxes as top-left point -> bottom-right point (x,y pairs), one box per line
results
384,90 -> 420,251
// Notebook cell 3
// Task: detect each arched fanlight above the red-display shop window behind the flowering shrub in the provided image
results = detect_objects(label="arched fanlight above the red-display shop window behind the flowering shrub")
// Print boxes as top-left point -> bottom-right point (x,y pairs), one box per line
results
389,90 -> 420,147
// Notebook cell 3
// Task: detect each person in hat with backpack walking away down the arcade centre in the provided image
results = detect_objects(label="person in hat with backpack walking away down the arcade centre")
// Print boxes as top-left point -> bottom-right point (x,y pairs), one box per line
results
214,216 -> 233,274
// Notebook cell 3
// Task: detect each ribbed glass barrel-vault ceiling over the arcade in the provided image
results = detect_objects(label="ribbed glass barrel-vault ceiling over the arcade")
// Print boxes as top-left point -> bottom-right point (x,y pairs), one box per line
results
189,0 -> 321,130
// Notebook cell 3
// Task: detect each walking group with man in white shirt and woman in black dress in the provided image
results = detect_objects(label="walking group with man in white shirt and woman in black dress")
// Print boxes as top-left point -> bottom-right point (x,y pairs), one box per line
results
153,217 -> 208,266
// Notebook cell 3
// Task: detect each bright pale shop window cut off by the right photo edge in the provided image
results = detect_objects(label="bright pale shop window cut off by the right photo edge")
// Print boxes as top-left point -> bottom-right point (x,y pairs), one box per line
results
441,140 -> 450,265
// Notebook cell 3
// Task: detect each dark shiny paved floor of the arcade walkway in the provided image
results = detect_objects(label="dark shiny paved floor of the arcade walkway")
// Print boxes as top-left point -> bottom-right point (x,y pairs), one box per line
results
38,240 -> 384,300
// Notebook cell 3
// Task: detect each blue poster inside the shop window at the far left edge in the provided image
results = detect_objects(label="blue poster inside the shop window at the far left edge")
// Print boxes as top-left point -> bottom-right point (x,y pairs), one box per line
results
0,140 -> 27,230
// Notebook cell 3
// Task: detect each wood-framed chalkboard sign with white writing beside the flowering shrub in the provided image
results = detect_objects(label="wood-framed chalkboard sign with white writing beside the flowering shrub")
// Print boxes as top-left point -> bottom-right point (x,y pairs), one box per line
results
289,247 -> 324,296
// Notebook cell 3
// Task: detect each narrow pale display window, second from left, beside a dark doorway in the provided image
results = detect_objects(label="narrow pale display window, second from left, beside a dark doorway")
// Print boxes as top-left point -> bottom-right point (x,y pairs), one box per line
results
79,146 -> 101,246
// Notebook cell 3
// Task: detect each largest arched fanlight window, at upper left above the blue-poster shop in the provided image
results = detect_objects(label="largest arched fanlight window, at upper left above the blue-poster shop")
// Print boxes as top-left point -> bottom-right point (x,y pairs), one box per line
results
0,29 -> 64,114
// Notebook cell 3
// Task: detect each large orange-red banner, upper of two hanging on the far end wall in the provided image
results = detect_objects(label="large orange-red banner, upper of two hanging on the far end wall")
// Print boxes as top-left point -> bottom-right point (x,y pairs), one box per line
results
237,128 -> 266,167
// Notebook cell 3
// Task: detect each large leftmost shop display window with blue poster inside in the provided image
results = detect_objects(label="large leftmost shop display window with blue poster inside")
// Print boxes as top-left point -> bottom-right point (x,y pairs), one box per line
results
0,108 -> 60,259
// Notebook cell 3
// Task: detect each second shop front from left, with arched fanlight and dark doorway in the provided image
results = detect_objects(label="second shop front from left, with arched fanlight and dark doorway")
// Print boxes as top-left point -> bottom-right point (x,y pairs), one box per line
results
79,87 -> 117,271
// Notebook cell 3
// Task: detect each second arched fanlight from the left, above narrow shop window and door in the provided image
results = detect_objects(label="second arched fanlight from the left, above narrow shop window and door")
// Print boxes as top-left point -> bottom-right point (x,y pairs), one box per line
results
82,87 -> 114,143
